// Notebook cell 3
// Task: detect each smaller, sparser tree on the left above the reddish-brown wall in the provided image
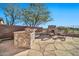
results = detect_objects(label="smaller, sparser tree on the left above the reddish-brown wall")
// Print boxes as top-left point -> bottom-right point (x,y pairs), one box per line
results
2,4 -> 21,25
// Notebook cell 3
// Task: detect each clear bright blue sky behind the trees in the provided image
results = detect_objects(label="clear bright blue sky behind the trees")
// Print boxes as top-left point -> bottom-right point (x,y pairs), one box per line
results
0,3 -> 79,28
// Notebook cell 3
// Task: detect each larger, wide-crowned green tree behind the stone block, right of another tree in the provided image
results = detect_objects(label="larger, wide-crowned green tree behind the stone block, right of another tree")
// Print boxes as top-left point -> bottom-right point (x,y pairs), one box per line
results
22,3 -> 52,27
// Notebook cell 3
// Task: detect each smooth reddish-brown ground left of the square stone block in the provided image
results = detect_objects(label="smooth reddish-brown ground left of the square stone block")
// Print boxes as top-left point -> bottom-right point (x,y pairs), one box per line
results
0,40 -> 26,56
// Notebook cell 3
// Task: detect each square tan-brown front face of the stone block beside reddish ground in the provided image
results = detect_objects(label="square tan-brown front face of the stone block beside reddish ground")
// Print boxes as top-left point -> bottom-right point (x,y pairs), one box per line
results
14,31 -> 31,48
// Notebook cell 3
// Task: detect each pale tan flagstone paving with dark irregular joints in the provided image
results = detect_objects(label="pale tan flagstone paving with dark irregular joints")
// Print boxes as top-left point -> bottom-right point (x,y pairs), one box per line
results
15,37 -> 79,56
